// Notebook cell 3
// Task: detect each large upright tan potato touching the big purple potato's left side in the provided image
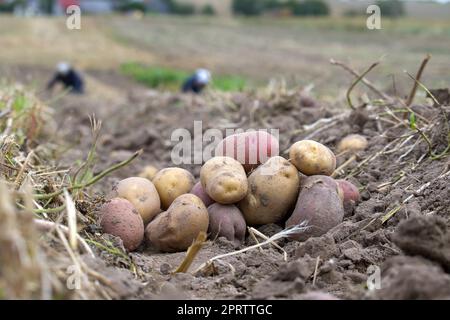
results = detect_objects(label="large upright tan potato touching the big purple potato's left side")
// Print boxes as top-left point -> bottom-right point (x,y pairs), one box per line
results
238,156 -> 300,225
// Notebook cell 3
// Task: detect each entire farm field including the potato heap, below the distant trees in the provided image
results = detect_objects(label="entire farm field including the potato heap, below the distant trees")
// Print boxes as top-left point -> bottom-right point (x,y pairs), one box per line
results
0,15 -> 450,300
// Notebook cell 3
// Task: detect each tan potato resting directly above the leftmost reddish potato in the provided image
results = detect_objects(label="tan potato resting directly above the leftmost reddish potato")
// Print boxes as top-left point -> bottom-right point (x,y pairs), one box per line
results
113,177 -> 161,224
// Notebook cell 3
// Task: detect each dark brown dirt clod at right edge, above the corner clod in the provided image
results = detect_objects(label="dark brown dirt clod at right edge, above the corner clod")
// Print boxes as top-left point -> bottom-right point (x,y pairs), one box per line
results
392,216 -> 450,272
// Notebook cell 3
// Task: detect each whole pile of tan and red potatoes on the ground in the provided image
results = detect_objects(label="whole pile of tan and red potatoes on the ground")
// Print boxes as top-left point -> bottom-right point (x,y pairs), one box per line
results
99,131 -> 367,252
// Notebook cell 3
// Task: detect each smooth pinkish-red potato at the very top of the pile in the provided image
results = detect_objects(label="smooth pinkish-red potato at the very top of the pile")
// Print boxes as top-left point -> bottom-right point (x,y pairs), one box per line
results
214,130 -> 279,172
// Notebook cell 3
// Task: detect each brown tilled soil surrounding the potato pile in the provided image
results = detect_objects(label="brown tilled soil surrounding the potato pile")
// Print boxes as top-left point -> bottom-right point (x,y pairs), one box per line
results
7,65 -> 450,299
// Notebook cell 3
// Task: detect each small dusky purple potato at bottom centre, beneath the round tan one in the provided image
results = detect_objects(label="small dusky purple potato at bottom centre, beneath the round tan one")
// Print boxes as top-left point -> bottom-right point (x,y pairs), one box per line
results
208,203 -> 247,244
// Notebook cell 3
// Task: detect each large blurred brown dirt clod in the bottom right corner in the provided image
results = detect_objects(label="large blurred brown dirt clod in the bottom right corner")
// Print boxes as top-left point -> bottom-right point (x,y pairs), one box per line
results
374,256 -> 450,300
